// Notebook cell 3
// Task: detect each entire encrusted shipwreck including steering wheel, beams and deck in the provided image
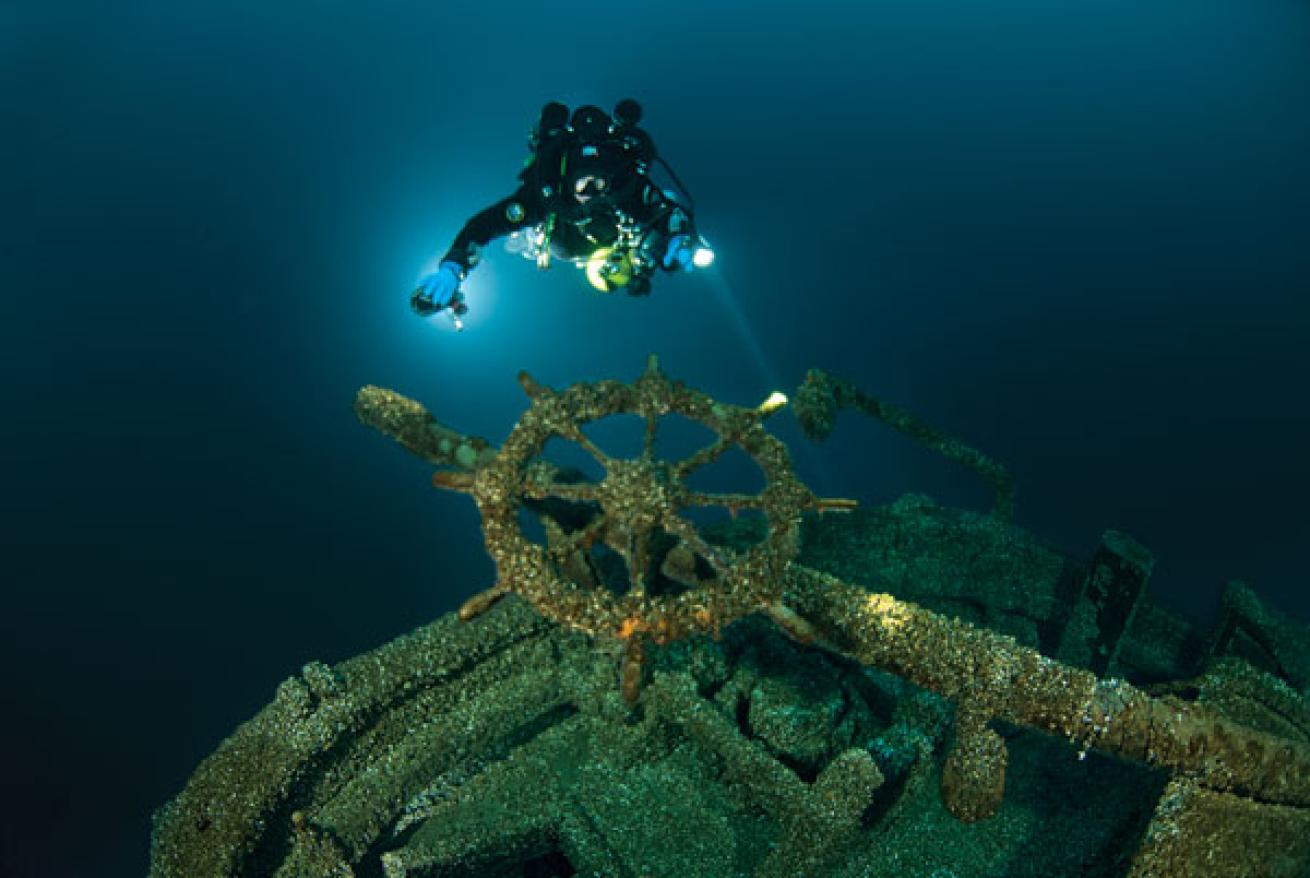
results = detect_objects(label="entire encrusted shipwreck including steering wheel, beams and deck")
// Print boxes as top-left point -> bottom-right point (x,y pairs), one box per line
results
151,359 -> 1310,878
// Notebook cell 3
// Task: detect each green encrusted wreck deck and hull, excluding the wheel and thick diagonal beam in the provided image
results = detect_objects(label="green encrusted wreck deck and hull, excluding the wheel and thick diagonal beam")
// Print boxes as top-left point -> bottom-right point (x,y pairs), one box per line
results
152,497 -> 1310,878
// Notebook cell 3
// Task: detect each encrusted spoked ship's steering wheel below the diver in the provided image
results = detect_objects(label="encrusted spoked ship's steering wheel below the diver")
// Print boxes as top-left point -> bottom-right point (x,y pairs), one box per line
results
419,356 -> 853,700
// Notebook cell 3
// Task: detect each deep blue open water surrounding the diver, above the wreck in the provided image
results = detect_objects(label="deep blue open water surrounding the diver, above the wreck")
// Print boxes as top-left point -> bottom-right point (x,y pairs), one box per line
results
0,0 -> 1310,878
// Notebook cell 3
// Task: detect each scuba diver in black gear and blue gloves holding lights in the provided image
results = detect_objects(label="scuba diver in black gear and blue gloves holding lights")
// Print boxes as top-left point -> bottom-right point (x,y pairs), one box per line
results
410,98 -> 714,329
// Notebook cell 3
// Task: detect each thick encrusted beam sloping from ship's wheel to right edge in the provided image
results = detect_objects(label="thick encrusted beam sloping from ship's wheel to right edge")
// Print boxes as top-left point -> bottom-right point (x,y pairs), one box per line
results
786,565 -> 1310,807
